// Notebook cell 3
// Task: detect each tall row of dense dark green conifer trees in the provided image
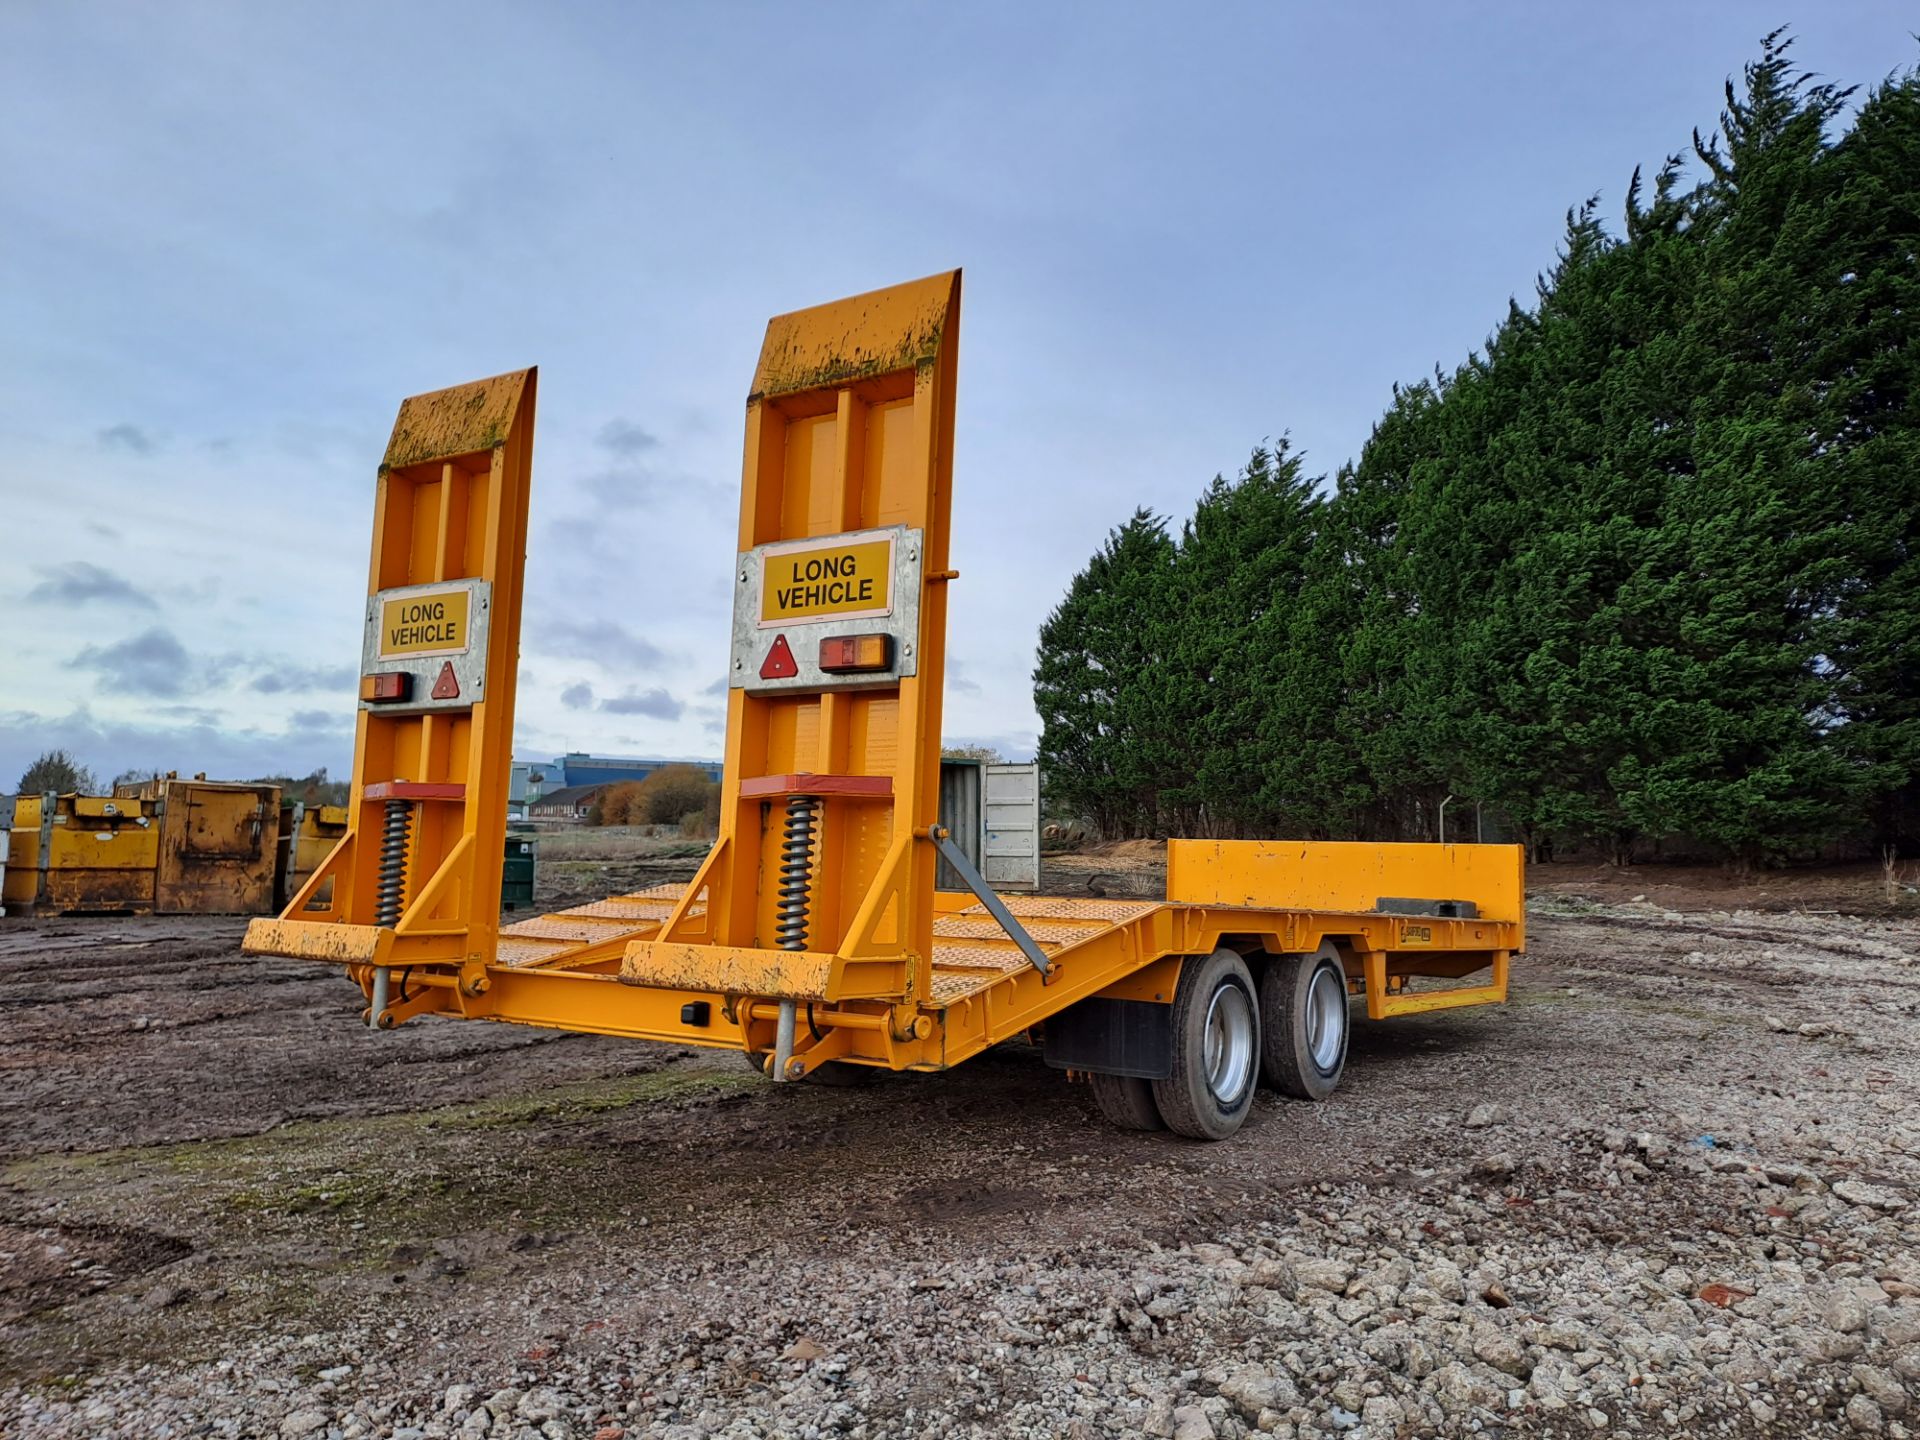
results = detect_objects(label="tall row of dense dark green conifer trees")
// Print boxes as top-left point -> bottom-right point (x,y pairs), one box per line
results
1033,36 -> 1920,862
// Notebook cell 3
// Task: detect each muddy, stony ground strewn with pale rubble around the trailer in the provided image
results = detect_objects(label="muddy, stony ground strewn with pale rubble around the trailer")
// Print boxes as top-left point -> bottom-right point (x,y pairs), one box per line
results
0,847 -> 1920,1440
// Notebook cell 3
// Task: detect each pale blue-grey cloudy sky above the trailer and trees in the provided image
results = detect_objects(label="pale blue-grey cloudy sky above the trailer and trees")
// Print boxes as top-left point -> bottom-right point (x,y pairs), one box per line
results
0,0 -> 1916,789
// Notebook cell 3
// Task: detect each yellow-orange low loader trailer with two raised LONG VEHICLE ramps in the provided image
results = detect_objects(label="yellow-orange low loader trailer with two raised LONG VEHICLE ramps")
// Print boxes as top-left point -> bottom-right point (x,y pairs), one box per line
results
246,271 -> 1524,1139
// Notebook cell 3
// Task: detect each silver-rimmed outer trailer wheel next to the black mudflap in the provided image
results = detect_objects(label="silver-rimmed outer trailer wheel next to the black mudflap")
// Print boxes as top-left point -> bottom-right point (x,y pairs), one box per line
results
1152,948 -> 1260,1140
